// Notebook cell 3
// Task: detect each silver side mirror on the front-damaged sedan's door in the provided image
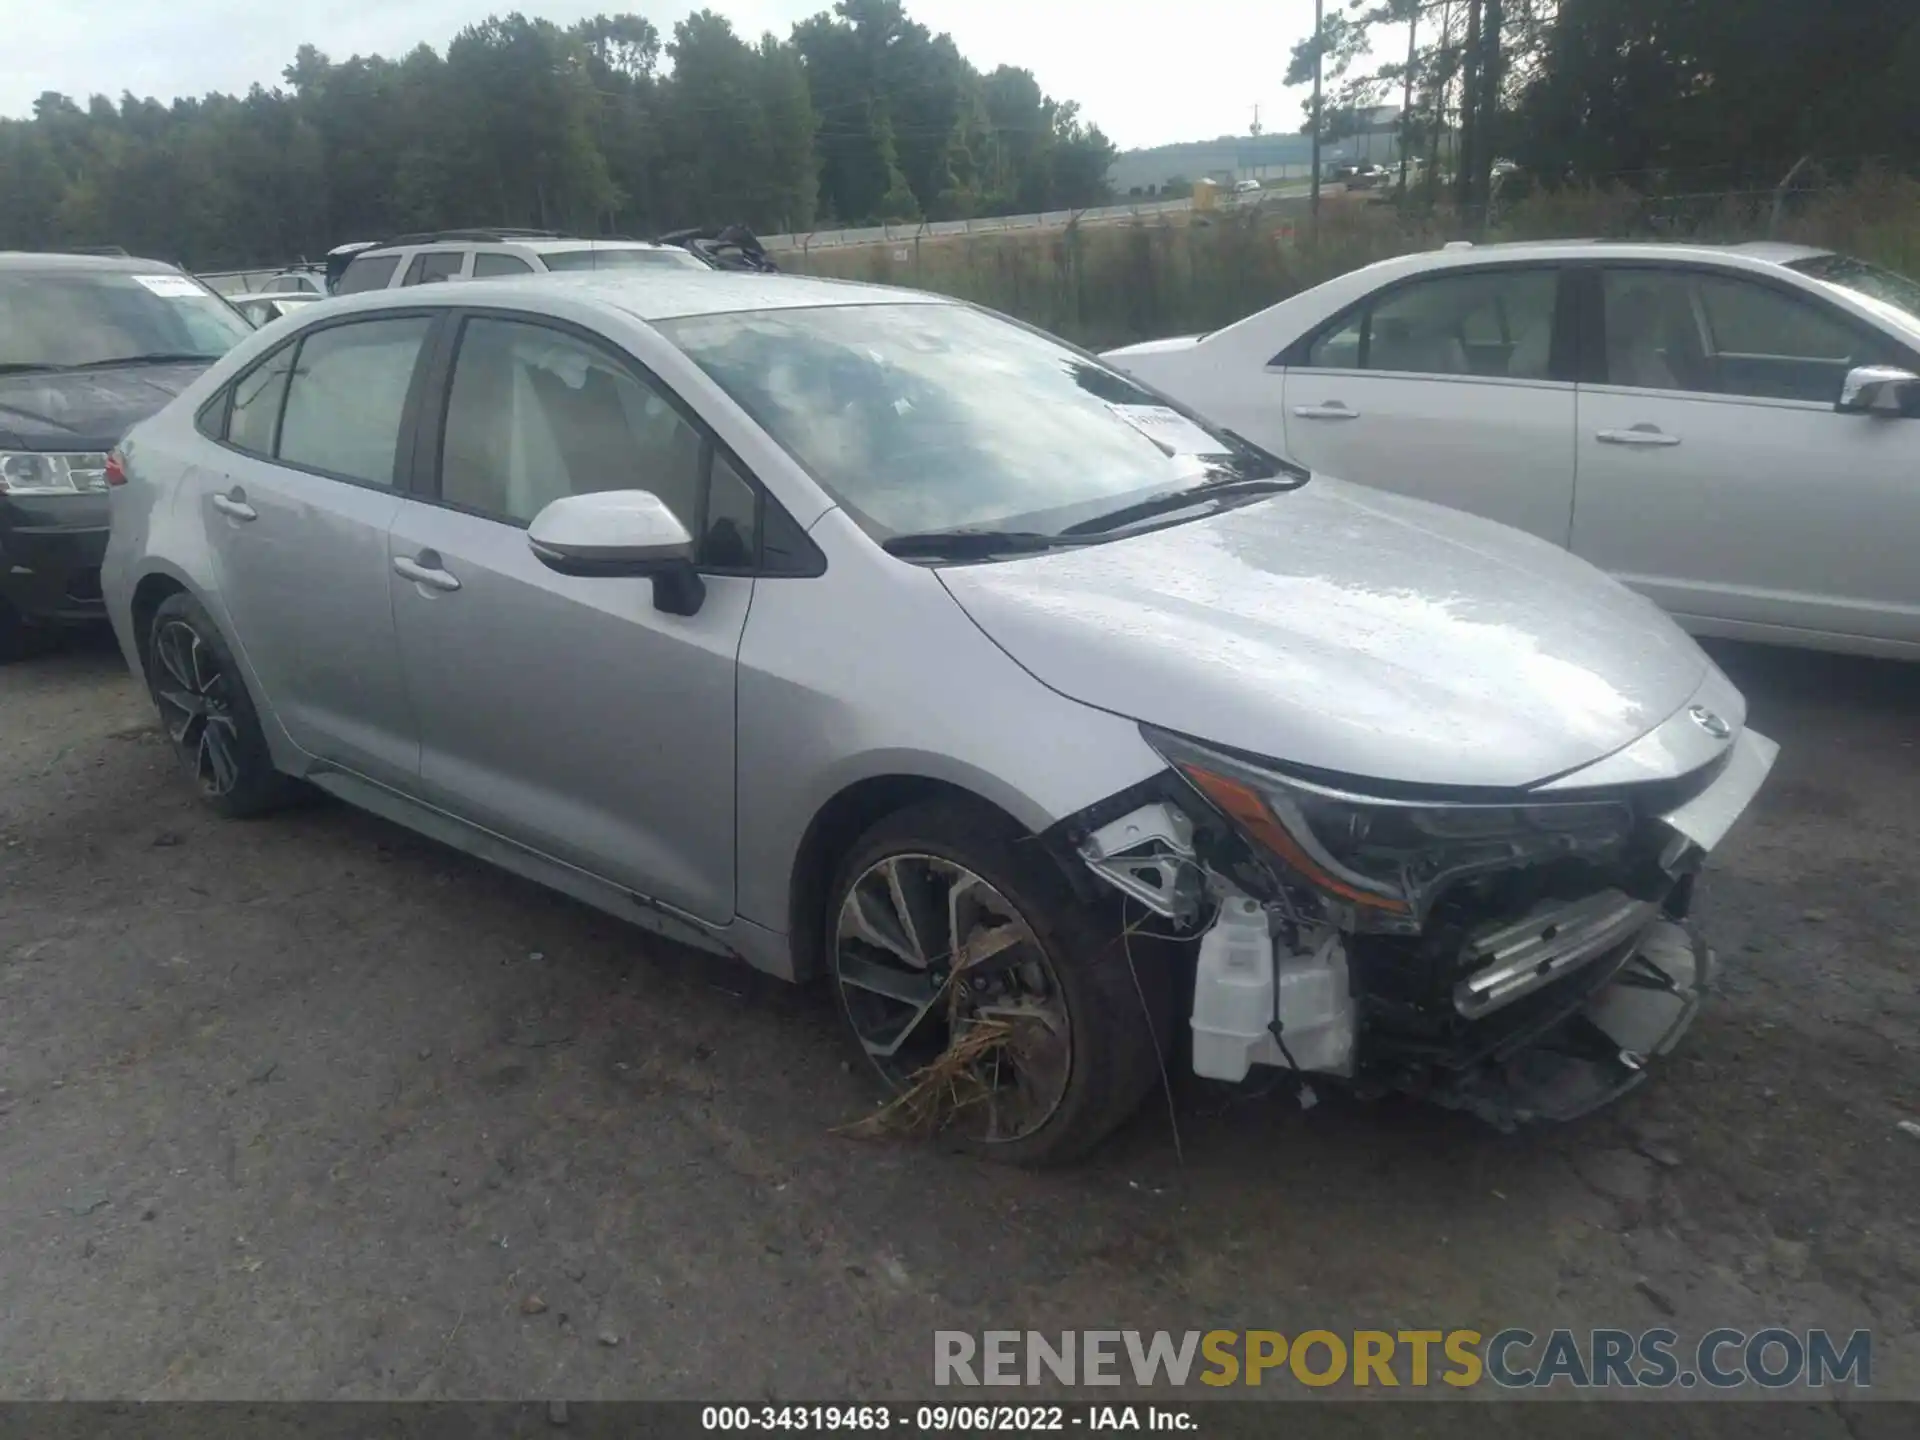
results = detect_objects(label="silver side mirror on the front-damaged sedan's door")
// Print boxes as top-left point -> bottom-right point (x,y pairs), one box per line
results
526,490 -> 707,614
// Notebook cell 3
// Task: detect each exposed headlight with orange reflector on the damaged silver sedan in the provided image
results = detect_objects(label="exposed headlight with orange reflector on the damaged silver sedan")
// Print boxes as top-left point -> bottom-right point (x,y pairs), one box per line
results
1140,726 -> 1634,935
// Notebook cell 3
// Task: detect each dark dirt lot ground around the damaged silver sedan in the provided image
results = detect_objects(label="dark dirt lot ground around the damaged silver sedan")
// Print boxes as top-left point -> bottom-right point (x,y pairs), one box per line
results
0,645 -> 1920,1436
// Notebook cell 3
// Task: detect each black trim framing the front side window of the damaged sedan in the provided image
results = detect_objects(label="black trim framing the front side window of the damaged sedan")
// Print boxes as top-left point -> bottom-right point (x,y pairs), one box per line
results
405,305 -> 828,580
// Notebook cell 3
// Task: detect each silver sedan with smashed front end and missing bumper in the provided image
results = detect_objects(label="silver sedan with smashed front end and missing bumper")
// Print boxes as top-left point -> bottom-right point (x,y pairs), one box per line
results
104,271 -> 1774,1162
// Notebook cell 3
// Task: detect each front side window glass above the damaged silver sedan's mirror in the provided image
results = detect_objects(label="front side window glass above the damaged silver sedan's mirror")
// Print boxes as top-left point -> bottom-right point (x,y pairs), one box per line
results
440,319 -> 705,534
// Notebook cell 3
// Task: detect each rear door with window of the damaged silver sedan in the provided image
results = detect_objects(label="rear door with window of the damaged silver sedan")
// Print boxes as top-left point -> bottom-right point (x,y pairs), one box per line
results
196,313 -> 434,789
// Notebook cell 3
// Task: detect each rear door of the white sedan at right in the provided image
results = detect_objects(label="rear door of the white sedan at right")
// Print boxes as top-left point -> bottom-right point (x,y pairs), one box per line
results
1277,265 -> 1574,545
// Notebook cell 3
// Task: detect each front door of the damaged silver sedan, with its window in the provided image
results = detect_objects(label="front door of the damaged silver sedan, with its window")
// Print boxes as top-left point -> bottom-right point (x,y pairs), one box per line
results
388,313 -> 770,924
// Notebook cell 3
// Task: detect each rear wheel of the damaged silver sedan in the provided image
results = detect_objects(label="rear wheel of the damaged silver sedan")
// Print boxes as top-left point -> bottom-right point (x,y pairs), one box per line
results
146,591 -> 294,820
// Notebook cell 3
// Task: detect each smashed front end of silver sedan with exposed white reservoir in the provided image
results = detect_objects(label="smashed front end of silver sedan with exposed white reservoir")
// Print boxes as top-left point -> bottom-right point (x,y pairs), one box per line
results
1069,707 -> 1778,1129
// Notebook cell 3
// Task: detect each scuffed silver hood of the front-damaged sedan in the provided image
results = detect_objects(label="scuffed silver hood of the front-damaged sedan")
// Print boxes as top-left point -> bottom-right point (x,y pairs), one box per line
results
939,478 -> 1711,787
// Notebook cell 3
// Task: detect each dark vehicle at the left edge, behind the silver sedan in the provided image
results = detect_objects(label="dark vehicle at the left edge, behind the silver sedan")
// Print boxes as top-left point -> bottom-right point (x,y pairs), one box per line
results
0,252 -> 252,660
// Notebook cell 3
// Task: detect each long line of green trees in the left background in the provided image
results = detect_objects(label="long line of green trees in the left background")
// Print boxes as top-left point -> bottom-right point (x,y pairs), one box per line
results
0,0 -> 1116,269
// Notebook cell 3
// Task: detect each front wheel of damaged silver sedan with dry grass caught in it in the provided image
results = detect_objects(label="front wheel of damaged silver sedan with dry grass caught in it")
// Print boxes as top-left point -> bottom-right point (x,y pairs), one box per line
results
826,801 -> 1169,1165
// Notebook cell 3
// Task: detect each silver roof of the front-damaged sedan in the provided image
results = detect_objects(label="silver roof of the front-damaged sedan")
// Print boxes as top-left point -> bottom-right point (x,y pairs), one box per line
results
309,267 -> 958,323
